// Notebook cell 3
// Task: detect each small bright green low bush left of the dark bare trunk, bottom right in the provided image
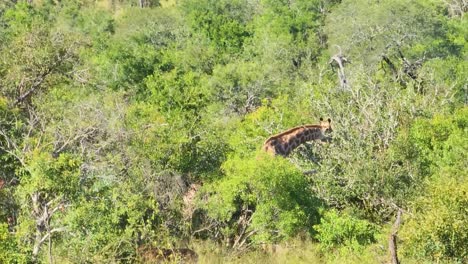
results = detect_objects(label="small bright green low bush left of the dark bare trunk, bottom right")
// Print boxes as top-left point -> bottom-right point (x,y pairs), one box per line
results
314,210 -> 378,251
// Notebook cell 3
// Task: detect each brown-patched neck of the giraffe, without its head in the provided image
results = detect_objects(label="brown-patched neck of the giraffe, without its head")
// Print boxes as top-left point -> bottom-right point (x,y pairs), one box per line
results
264,125 -> 324,156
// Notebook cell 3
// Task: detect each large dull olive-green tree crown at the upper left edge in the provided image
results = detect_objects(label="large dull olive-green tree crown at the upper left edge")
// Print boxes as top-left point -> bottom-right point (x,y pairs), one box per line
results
0,3 -> 82,105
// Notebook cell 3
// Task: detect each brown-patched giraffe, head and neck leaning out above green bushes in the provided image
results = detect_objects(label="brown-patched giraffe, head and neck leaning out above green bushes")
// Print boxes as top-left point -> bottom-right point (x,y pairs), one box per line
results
262,118 -> 333,157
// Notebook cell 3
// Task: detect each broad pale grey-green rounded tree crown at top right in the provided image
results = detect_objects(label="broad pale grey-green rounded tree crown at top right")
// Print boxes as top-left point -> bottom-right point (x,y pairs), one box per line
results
326,0 -> 458,67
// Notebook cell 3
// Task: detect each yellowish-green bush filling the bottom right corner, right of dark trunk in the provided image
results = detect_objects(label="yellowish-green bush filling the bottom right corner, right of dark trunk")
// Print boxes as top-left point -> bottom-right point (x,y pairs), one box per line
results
401,177 -> 468,263
